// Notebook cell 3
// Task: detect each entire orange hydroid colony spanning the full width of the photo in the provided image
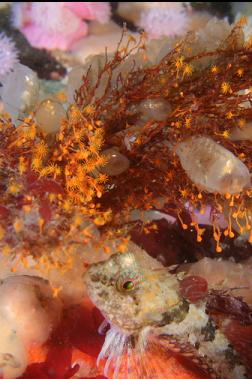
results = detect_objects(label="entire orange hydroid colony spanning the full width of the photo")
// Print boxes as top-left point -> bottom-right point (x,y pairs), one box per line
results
0,20 -> 252,270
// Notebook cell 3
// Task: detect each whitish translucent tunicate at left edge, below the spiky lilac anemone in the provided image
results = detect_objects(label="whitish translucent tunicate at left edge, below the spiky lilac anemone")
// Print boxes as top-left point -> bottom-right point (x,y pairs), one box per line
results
1,63 -> 39,120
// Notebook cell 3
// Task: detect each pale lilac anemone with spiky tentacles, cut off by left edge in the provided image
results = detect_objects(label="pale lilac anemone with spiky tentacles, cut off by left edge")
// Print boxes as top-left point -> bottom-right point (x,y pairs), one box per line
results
0,33 -> 18,80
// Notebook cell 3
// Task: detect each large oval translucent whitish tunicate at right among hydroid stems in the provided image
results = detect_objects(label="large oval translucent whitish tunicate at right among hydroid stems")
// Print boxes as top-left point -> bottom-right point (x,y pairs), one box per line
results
176,137 -> 251,194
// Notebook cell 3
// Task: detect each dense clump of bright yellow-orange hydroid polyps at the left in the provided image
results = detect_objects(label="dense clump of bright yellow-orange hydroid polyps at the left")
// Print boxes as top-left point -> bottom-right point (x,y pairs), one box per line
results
0,102 -> 110,270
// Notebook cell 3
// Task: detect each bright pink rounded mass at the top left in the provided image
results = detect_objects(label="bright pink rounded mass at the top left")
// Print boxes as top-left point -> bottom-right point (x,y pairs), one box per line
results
12,2 -> 110,50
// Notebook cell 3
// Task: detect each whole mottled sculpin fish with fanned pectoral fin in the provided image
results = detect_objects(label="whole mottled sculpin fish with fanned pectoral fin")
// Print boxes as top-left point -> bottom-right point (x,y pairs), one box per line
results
85,253 -> 248,379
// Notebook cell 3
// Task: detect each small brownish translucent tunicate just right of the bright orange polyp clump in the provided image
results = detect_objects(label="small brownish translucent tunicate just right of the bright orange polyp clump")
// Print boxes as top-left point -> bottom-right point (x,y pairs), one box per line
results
101,148 -> 130,176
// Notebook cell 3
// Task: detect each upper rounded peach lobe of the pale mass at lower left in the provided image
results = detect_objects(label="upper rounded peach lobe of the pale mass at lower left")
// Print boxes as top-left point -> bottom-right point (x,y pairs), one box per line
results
0,275 -> 61,344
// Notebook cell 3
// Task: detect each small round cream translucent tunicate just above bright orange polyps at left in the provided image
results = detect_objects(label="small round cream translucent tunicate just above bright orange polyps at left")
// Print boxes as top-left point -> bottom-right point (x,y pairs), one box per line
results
35,99 -> 66,133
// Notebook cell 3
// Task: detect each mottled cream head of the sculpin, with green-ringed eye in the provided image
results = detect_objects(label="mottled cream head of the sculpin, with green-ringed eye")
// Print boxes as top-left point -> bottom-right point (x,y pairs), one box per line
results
85,253 -> 185,333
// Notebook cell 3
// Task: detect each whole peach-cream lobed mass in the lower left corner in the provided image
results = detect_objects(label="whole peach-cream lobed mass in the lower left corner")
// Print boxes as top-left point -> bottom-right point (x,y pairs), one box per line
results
0,275 -> 61,379
